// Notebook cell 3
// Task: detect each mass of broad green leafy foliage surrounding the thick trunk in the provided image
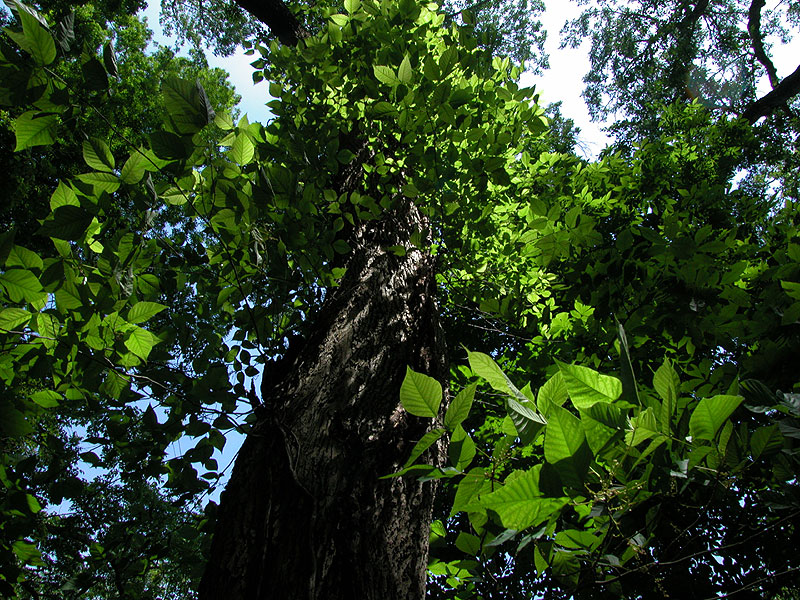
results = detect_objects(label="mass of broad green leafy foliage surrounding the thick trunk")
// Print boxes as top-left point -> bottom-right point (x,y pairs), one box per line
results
0,0 -> 800,598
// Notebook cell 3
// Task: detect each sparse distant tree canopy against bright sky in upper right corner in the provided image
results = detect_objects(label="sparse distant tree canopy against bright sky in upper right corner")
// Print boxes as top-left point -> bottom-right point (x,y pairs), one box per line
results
562,0 -> 800,206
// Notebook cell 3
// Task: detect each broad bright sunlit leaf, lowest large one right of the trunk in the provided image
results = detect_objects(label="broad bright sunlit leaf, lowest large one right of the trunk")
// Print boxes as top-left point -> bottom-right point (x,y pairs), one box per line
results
476,465 -> 568,531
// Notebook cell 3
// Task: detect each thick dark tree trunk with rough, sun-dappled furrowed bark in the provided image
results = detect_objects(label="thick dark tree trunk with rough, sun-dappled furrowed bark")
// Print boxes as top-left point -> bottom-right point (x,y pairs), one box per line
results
200,199 -> 447,600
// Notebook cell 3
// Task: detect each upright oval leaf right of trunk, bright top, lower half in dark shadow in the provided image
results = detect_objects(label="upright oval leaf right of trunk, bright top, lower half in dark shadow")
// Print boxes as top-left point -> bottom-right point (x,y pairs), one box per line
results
544,407 -> 592,489
